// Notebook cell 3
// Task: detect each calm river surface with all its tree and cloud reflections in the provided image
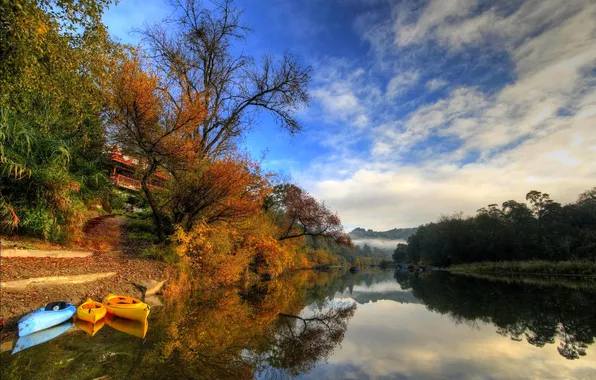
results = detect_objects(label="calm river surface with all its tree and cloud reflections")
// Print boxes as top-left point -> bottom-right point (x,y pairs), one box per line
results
1,270 -> 596,380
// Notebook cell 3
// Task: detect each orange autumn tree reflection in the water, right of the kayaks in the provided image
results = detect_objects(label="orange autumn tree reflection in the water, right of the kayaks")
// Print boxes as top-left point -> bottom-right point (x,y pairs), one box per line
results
147,271 -> 356,379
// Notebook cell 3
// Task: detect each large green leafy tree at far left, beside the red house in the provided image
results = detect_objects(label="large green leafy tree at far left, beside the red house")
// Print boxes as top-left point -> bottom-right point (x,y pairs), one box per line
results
0,0 -> 119,240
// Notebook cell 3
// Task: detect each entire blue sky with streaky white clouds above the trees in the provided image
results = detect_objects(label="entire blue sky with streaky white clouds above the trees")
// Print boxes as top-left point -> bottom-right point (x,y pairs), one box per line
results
104,0 -> 596,230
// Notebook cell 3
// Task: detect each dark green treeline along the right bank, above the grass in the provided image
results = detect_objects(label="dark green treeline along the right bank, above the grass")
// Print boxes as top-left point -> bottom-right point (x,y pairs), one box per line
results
393,187 -> 596,266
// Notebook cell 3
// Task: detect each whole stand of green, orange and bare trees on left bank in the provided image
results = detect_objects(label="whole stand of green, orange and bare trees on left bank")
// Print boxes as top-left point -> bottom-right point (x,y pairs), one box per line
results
0,0 -> 364,282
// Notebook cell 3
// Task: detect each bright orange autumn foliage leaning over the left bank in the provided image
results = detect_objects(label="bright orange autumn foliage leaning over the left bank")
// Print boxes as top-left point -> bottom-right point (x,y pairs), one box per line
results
108,54 -> 343,280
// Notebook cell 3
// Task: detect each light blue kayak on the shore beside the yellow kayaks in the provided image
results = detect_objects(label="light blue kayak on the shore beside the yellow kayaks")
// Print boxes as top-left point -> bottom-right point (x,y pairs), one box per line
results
19,302 -> 77,336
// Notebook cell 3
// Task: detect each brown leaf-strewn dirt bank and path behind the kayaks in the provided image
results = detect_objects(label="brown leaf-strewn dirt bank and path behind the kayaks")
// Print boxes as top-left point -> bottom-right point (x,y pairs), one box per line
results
0,216 -> 173,334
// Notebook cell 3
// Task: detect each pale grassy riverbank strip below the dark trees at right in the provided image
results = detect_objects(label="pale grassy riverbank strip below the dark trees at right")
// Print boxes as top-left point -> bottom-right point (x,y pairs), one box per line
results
448,260 -> 596,278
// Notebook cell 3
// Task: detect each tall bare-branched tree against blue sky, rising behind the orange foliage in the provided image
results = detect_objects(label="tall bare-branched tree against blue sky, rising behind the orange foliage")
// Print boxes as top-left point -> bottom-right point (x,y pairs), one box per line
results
137,0 -> 310,157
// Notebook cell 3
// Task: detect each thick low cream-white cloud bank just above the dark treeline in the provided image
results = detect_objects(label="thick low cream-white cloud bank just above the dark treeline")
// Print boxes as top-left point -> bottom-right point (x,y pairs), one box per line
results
313,107 -> 596,230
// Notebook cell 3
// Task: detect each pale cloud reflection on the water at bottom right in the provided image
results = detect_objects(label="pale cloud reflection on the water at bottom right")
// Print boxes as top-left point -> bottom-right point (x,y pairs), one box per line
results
310,298 -> 596,379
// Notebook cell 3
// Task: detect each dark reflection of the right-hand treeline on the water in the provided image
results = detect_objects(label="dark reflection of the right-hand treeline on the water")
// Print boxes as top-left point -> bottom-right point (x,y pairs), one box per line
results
394,272 -> 596,359
